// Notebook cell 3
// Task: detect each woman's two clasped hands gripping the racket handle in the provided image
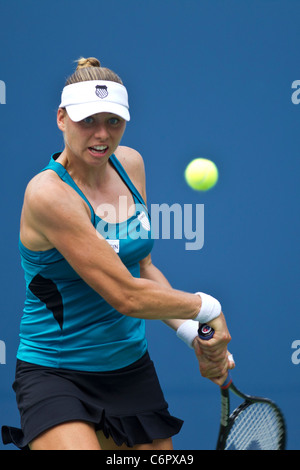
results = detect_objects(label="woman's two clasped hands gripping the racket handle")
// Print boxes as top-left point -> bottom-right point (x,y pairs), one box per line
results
193,313 -> 235,385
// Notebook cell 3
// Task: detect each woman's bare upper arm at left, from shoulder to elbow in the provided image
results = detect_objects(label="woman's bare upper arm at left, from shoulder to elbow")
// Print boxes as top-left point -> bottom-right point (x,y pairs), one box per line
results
26,174 -> 137,313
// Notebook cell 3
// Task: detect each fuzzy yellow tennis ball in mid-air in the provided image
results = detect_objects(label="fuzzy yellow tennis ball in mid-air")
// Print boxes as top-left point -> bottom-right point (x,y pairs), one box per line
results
184,158 -> 219,191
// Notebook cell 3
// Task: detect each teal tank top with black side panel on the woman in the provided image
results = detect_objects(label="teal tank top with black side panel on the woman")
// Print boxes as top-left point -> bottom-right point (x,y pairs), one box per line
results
17,153 -> 153,372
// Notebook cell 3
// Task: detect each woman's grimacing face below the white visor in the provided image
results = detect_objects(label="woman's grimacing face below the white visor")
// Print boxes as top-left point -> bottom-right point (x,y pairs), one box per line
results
57,108 -> 126,165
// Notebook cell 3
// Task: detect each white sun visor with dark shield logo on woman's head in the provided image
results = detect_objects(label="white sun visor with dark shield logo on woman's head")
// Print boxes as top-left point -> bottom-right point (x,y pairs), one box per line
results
59,80 -> 130,122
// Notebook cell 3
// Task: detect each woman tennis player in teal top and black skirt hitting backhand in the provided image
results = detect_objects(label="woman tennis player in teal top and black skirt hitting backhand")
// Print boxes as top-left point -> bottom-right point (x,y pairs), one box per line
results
2,58 -> 233,450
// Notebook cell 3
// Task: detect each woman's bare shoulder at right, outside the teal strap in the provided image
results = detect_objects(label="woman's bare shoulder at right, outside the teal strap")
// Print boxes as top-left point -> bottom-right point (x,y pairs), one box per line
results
115,146 -> 146,200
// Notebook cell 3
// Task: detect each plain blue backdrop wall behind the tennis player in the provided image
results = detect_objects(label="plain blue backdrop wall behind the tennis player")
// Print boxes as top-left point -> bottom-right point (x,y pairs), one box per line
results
0,0 -> 300,450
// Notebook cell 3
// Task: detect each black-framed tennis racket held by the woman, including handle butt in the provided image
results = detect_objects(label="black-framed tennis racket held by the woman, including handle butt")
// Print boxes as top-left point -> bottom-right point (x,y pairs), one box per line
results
198,325 -> 286,450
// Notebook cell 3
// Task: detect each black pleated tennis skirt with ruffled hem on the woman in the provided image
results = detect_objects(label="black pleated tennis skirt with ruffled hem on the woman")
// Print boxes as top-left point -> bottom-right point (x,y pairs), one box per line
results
2,353 -> 183,450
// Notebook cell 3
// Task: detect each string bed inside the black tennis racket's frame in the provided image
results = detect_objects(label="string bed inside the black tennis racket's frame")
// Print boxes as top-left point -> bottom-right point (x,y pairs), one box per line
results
225,403 -> 284,450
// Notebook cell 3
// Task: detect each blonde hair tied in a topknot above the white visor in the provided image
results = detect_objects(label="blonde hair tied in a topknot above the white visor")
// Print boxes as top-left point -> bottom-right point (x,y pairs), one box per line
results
66,57 -> 123,86
